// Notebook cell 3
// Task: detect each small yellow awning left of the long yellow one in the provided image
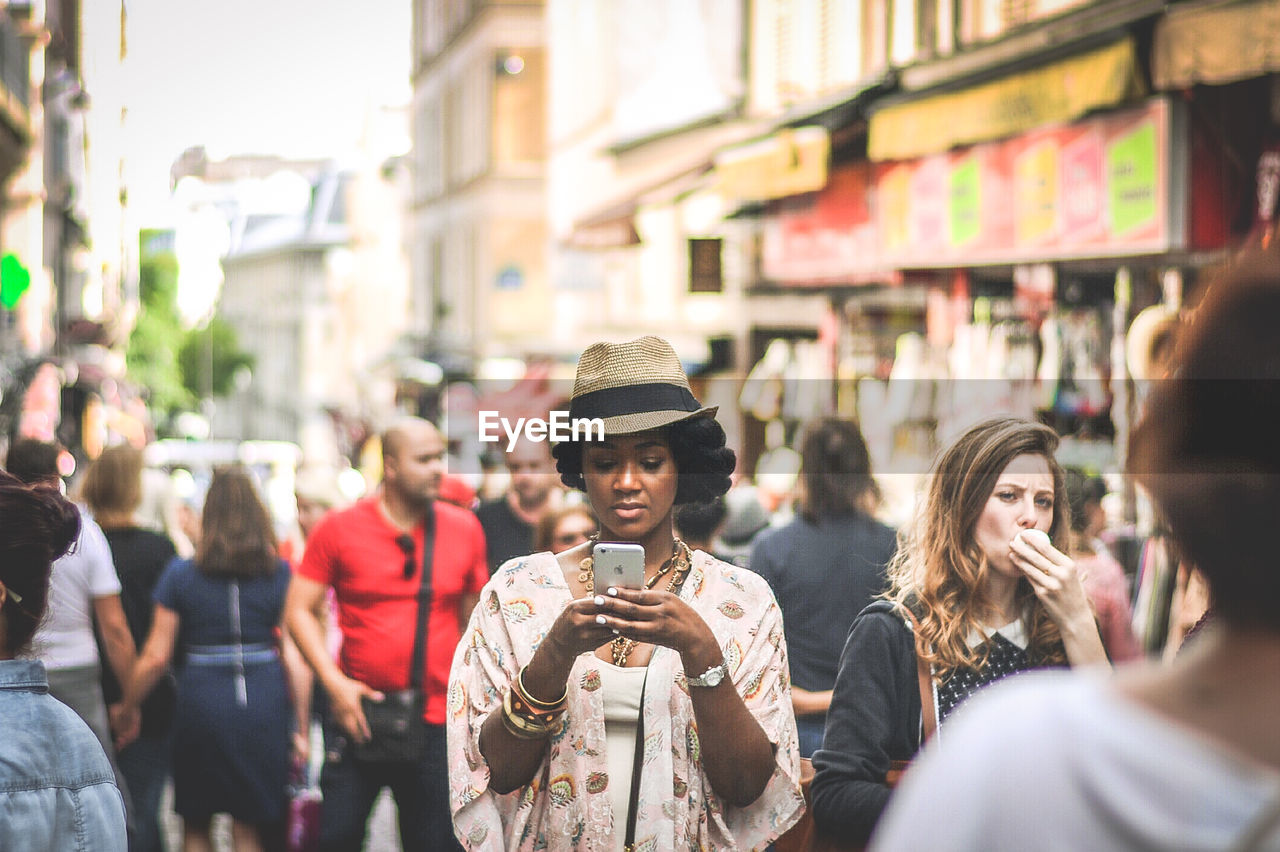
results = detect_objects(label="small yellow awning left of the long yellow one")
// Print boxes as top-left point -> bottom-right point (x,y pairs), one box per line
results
716,127 -> 831,203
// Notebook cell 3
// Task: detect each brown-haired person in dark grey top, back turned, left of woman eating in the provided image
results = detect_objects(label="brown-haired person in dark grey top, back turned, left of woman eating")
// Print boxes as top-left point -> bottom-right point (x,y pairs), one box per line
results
749,417 -> 895,757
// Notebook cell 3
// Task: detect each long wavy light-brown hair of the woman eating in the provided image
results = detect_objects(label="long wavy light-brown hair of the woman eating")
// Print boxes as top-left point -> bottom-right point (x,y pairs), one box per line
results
888,417 -> 1070,679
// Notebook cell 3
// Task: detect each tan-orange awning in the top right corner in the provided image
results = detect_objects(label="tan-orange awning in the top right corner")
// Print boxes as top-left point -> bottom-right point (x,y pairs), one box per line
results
1151,0 -> 1280,90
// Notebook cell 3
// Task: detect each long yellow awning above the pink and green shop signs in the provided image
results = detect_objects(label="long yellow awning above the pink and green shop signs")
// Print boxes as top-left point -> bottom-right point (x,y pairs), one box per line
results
867,38 -> 1143,160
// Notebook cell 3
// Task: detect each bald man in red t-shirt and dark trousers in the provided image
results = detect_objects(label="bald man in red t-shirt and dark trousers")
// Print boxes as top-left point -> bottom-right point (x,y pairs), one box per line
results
285,418 -> 489,852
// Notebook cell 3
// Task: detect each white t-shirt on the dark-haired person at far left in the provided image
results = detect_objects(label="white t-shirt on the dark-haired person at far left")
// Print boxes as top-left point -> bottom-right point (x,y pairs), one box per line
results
28,508 -> 120,670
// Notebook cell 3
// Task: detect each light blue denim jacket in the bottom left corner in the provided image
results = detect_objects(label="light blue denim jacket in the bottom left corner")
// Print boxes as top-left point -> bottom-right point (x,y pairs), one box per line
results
0,660 -> 128,852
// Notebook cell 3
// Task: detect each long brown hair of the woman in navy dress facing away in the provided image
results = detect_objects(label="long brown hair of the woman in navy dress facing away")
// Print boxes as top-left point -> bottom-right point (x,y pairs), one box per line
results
196,467 -> 280,578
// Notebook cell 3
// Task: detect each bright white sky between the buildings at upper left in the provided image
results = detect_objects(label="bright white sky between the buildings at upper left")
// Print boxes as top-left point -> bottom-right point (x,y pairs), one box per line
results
117,0 -> 411,226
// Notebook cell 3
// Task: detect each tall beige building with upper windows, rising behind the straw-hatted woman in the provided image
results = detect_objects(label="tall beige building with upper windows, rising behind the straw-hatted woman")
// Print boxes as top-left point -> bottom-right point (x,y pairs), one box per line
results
406,0 -> 550,362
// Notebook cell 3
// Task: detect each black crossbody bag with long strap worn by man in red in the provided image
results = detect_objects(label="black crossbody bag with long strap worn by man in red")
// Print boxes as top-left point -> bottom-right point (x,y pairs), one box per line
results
355,507 -> 435,764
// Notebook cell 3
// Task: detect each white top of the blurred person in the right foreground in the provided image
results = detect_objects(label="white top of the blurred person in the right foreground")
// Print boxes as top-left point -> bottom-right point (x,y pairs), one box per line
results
872,672 -> 1280,852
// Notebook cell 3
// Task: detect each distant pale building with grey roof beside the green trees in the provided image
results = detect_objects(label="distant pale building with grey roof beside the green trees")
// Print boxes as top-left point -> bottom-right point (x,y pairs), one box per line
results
211,138 -> 408,464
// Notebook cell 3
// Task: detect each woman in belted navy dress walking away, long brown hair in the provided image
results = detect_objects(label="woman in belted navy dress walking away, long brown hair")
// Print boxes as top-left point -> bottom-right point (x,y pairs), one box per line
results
122,467 -> 305,852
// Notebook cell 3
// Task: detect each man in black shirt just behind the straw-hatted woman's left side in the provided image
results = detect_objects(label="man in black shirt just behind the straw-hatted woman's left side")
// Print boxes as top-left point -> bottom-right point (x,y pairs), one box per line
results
476,438 -> 559,573
